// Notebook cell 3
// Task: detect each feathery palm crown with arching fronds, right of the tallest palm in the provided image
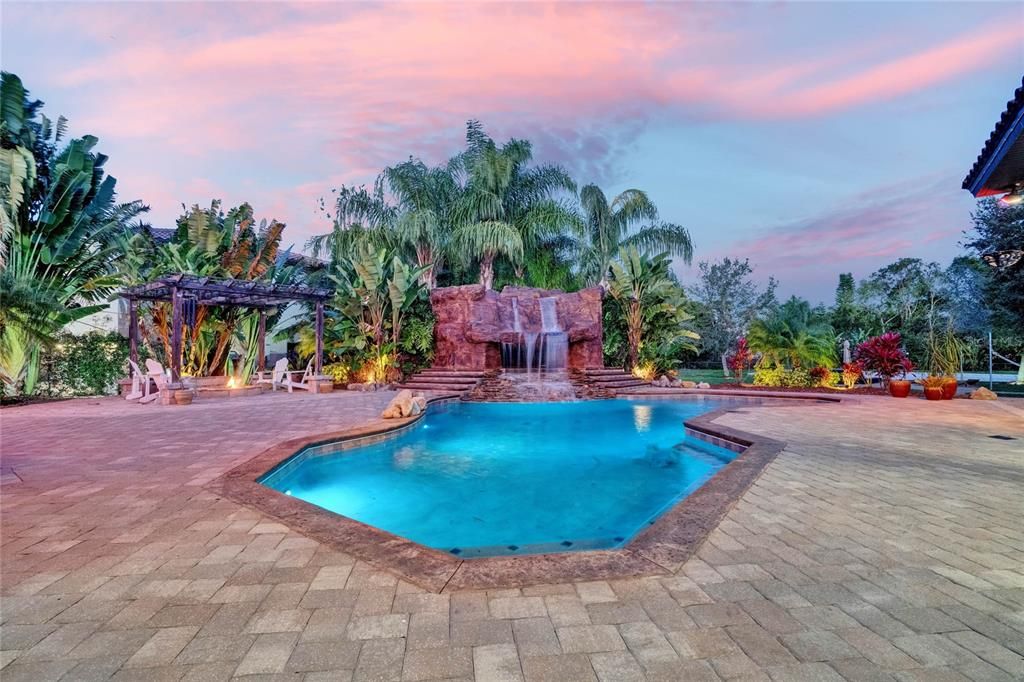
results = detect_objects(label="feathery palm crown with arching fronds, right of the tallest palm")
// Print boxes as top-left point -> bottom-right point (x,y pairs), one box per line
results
579,184 -> 693,289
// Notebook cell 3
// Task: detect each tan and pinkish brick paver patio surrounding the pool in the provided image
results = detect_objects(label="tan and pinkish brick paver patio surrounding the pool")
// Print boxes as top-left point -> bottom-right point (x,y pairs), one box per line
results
0,393 -> 1024,682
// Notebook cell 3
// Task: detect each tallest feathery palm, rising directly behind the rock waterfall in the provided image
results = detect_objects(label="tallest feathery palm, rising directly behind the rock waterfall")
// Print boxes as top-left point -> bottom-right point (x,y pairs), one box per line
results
453,121 -> 575,289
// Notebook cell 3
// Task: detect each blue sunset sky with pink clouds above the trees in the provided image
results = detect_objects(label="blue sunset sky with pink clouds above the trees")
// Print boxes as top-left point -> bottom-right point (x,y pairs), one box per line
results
0,0 -> 1024,302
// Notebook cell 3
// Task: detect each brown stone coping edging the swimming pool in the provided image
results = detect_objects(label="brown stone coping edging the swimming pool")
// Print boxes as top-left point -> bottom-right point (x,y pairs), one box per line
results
206,389 -> 823,592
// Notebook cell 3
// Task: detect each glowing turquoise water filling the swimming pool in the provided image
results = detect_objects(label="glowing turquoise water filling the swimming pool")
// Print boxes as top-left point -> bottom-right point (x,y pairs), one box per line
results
261,400 -> 736,557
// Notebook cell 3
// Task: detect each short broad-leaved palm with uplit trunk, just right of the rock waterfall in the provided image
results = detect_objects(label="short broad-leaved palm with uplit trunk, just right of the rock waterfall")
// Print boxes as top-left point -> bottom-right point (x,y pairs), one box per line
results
607,246 -> 699,369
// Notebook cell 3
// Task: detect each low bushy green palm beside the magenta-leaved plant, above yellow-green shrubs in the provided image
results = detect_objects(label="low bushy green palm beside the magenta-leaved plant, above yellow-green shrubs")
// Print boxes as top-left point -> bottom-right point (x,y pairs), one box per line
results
746,297 -> 836,368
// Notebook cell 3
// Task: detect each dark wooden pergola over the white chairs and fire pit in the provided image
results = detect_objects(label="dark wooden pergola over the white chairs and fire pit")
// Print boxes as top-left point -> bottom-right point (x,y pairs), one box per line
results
121,273 -> 331,381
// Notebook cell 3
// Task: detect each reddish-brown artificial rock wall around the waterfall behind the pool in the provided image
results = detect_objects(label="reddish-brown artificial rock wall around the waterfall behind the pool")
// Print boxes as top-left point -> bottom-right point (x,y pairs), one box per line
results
430,285 -> 604,370
